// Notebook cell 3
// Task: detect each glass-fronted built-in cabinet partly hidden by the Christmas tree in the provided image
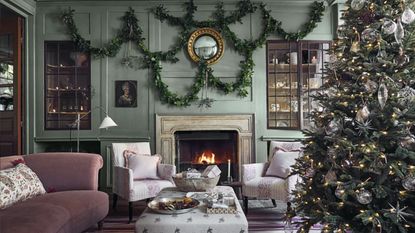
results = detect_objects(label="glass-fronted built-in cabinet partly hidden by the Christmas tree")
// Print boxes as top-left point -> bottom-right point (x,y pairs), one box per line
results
267,41 -> 330,129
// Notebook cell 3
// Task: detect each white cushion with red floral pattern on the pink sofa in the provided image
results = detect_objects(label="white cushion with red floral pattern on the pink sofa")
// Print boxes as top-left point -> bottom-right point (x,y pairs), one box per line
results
0,163 -> 46,209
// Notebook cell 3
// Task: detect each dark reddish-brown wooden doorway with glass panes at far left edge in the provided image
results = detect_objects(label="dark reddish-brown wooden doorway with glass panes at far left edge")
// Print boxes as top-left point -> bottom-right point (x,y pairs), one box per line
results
0,4 -> 25,156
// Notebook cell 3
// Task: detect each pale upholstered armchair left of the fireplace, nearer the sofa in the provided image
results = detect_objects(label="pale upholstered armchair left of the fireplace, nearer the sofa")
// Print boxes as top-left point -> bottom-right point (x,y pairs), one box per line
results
112,142 -> 176,222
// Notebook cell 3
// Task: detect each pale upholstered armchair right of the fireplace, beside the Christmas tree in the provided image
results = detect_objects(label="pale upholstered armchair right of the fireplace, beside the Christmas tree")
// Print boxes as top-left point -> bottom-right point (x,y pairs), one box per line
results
242,141 -> 302,213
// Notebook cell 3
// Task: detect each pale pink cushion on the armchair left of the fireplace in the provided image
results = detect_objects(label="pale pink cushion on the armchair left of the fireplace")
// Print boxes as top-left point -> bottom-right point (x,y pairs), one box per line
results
127,154 -> 160,180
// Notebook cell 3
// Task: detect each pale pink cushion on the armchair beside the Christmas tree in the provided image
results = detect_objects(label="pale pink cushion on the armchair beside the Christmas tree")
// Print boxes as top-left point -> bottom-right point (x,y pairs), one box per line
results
265,150 -> 300,179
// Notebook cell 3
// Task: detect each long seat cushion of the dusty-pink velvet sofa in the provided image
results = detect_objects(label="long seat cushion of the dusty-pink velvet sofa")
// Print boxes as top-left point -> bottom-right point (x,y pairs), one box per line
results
0,190 -> 109,233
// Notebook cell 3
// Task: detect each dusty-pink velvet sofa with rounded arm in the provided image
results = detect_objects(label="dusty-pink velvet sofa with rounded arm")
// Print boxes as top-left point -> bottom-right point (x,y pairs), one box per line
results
0,153 -> 109,233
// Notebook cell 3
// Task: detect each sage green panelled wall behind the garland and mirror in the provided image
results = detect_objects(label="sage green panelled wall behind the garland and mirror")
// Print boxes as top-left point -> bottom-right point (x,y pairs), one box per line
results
30,1 -> 337,186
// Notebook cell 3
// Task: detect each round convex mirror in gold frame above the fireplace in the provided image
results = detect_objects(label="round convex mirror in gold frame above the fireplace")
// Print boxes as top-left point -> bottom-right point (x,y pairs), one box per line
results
187,27 -> 225,65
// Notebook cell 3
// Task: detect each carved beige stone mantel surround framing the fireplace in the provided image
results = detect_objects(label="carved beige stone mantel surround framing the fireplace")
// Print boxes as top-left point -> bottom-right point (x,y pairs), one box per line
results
156,114 -> 255,177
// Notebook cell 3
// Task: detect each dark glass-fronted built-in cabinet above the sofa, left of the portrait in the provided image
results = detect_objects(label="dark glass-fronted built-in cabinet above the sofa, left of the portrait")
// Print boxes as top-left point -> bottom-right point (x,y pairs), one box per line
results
44,41 -> 91,130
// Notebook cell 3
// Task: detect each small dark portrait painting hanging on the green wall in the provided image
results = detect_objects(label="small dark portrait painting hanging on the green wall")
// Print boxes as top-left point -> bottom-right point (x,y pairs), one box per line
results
115,80 -> 137,108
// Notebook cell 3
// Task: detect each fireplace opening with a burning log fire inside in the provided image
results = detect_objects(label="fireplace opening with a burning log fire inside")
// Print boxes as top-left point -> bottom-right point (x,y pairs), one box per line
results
175,130 -> 239,181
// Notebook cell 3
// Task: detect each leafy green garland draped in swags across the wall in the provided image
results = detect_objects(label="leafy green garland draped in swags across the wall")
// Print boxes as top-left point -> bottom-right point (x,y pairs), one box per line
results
61,0 -> 325,107
